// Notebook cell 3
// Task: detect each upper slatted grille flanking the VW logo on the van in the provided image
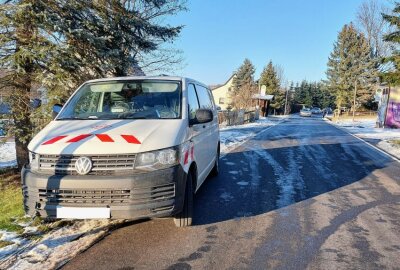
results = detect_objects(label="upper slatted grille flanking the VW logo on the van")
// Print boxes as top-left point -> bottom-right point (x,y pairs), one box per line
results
39,154 -> 136,175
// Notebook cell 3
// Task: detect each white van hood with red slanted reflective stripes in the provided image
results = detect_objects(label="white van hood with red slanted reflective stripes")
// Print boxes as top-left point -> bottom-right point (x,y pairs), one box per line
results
28,119 -> 186,155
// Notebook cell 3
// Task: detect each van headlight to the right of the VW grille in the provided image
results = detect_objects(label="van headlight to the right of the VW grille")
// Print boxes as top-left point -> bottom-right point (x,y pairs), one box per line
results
135,147 -> 179,171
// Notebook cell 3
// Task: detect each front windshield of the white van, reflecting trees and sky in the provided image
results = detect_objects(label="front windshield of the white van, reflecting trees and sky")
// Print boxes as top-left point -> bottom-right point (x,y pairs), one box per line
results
57,81 -> 182,120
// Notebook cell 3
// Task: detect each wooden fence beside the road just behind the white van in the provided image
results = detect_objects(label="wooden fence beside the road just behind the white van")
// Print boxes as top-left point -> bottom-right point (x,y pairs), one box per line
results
218,109 -> 259,126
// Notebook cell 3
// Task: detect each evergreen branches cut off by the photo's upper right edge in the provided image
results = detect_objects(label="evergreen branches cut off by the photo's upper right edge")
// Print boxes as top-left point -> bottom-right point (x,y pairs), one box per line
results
381,3 -> 400,85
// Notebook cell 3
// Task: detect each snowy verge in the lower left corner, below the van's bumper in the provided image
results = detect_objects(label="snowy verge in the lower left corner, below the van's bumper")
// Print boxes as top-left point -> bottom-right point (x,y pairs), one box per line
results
0,220 -> 123,270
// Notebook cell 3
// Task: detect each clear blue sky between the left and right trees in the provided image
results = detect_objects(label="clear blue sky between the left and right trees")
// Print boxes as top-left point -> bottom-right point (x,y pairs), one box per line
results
171,0 -> 376,84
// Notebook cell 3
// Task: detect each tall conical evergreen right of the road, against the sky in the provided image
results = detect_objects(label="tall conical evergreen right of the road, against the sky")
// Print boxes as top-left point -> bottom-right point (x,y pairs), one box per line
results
327,24 -> 377,110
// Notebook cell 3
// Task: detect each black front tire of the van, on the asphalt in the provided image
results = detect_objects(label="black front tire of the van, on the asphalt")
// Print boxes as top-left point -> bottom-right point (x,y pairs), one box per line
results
174,171 -> 193,227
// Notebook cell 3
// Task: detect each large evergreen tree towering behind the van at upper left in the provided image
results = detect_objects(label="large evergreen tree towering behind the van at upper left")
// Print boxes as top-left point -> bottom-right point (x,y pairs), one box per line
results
0,0 -> 184,168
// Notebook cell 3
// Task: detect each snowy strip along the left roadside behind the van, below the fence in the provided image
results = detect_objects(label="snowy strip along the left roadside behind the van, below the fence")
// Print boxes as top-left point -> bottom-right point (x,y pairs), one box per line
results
219,116 -> 286,155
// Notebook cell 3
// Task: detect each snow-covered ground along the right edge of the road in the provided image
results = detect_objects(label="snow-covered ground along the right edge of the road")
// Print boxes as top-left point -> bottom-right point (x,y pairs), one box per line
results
332,119 -> 400,158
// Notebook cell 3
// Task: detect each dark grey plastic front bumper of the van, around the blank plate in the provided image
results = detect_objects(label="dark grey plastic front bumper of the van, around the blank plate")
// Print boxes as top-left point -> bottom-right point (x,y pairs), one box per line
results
21,165 -> 187,219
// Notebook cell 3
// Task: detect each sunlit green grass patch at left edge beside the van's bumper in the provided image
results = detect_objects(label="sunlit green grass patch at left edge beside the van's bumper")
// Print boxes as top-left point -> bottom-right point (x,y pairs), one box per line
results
0,185 -> 25,233
